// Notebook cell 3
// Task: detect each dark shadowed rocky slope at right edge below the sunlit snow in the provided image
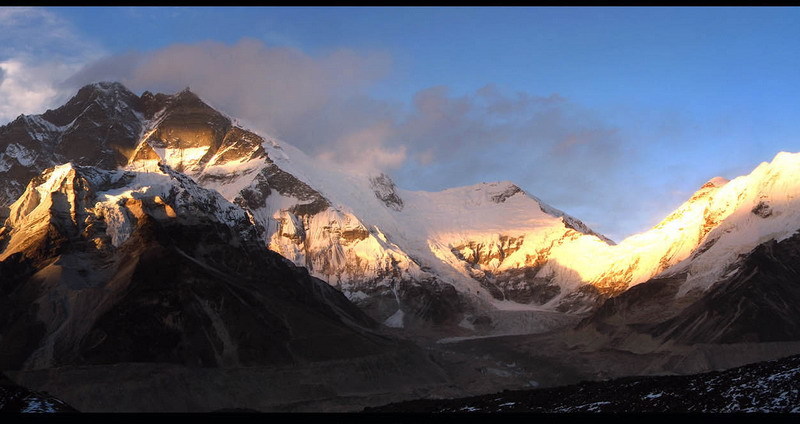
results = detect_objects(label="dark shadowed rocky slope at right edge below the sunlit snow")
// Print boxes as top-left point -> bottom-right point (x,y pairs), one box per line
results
579,234 -> 800,345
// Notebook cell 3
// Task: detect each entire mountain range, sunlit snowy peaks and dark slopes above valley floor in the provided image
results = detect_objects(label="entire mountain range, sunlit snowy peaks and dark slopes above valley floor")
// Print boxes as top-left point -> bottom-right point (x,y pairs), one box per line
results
0,82 -> 800,410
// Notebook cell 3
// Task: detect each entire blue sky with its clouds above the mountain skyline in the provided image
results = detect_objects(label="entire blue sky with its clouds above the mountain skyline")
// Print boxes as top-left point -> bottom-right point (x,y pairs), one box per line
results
0,7 -> 800,240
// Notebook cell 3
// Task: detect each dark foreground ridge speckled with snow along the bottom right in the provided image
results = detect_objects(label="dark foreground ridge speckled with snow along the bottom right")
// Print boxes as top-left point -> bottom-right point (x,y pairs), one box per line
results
364,355 -> 800,413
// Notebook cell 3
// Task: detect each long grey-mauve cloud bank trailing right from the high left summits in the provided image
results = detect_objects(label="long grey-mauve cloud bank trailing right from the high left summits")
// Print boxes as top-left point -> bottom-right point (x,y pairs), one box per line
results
65,39 -> 628,179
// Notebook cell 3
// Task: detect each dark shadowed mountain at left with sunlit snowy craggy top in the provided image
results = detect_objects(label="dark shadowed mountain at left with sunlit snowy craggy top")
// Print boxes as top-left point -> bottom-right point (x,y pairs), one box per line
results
0,165 -> 393,370
